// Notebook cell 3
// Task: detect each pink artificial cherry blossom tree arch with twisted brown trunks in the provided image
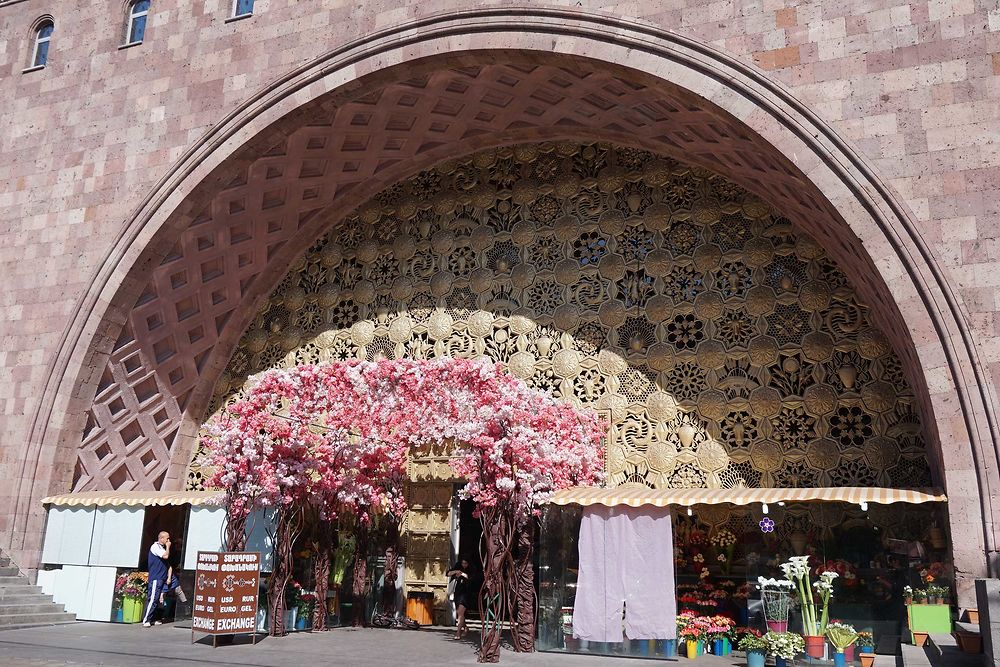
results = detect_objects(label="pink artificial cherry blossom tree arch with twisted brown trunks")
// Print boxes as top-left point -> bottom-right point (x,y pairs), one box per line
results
198,359 -> 604,662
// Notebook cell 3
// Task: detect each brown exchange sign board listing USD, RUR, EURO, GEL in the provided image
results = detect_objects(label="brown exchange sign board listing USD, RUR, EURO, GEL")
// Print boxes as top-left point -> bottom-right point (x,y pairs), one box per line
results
191,551 -> 260,641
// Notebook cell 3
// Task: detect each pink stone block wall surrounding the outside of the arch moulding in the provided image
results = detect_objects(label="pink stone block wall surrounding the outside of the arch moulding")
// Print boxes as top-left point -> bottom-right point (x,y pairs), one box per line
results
0,0 -> 1000,576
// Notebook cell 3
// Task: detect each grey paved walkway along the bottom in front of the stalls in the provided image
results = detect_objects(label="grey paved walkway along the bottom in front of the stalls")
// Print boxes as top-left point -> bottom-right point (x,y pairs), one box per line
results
0,623 -> 743,667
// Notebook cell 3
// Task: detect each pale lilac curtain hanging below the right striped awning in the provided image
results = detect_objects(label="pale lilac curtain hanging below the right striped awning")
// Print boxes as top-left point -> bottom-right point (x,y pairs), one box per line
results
573,505 -> 677,642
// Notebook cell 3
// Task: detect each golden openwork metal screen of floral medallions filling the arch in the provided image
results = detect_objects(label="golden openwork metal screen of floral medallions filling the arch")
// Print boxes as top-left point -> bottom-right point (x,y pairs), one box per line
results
188,142 -> 929,496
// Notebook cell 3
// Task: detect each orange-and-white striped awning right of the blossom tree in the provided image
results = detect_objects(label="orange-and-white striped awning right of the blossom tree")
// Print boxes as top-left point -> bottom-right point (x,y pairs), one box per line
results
549,485 -> 948,507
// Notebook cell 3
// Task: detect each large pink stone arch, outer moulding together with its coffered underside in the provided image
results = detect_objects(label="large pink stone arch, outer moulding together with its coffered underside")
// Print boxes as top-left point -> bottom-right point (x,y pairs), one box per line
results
13,8 -> 998,596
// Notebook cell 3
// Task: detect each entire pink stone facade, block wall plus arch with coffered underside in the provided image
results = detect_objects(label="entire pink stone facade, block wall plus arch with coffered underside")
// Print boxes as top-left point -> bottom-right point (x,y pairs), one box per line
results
0,0 -> 1000,604
